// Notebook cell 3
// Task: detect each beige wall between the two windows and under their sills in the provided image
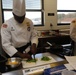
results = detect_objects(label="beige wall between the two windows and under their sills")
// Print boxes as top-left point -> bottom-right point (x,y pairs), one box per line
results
0,0 -> 69,30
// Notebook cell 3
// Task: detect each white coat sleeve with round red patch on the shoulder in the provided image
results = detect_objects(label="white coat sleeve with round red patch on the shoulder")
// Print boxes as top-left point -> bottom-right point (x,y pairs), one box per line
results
1,24 -> 17,57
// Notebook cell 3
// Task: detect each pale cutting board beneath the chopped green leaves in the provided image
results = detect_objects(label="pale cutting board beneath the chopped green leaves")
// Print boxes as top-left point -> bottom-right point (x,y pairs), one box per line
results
22,56 -> 56,68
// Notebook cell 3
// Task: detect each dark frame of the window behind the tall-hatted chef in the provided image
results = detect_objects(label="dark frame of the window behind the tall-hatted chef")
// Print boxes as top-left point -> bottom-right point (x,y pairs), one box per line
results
1,0 -> 44,26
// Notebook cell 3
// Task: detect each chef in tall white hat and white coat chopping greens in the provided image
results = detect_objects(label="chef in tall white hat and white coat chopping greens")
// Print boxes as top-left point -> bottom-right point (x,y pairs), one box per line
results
1,0 -> 38,59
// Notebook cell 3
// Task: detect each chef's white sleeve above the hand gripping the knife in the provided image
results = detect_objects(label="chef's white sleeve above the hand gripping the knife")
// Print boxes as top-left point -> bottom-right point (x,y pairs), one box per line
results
31,21 -> 38,46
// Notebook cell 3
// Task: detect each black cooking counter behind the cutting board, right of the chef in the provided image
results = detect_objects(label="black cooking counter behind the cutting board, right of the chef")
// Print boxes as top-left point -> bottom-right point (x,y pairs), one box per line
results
37,34 -> 73,58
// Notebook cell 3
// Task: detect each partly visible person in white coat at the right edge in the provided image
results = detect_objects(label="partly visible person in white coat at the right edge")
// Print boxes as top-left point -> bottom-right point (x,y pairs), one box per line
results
70,19 -> 76,56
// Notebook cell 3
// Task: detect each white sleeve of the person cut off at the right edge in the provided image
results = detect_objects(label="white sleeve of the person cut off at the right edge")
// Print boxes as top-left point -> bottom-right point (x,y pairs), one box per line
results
70,20 -> 76,42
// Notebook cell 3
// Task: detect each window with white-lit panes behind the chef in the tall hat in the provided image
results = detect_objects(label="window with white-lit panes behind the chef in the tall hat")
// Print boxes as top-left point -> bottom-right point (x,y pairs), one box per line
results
2,0 -> 44,26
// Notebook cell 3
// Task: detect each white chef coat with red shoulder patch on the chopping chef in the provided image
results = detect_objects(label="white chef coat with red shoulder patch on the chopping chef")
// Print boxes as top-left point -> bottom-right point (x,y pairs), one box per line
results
1,17 -> 38,57
